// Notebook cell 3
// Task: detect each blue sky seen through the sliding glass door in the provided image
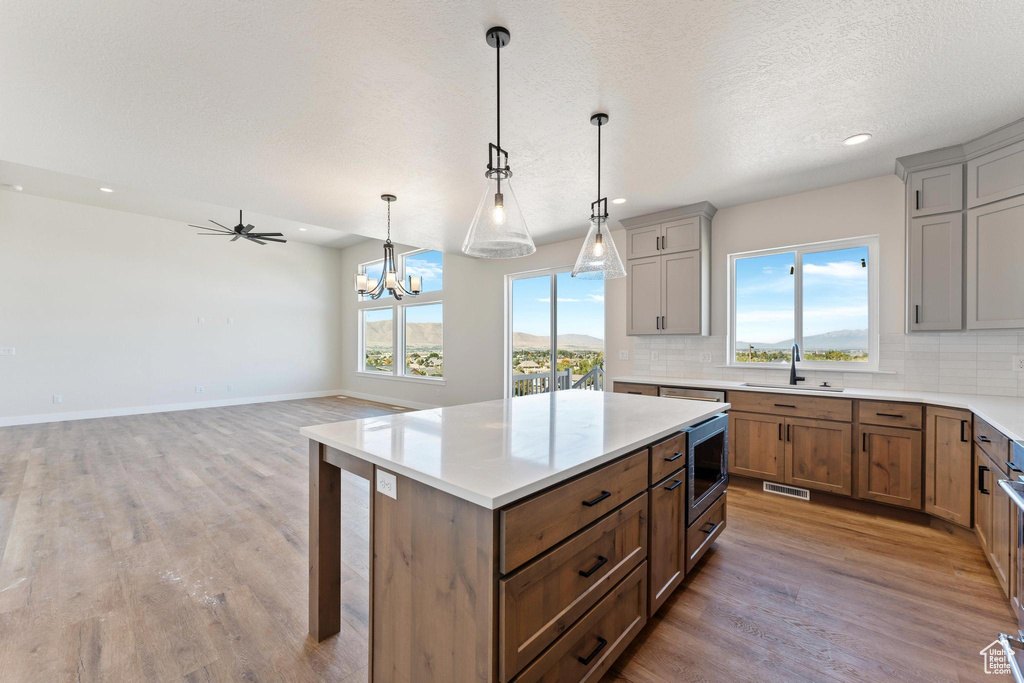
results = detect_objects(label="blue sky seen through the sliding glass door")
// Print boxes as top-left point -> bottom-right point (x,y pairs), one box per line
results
512,272 -> 604,339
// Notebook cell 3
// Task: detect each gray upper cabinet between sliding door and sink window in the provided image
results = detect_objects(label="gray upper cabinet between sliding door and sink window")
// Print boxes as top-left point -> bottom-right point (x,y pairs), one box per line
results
622,202 -> 717,335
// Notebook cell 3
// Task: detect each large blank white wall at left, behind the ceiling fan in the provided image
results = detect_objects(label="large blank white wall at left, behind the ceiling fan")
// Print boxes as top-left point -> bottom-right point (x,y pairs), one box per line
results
0,191 -> 350,423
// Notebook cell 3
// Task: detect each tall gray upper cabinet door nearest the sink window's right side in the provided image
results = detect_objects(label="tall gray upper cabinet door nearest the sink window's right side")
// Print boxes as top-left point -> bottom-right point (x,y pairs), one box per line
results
907,213 -> 964,331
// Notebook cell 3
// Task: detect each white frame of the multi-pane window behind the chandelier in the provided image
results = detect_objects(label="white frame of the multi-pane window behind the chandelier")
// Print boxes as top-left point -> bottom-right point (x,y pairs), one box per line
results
354,249 -> 446,385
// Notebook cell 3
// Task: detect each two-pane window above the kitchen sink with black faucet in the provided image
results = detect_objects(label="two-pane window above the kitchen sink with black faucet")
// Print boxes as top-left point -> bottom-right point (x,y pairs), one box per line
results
729,238 -> 878,370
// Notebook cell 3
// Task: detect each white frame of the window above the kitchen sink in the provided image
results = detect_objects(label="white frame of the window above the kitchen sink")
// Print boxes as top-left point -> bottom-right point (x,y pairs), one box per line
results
725,234 -> 881,373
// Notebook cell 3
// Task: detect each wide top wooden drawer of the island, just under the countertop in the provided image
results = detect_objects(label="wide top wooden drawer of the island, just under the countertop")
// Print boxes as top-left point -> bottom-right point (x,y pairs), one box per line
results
500,449 -> 647,573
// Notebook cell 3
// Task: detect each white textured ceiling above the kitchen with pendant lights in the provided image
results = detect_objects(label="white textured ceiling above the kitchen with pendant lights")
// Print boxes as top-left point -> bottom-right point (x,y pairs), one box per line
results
0,0 -> 1024,250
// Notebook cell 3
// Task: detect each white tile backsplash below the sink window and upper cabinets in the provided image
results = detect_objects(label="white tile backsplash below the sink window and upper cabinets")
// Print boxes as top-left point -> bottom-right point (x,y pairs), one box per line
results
632,330 -> 1024,396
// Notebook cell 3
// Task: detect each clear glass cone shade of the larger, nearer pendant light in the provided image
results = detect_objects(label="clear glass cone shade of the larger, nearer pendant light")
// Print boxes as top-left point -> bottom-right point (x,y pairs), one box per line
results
462,178 -> 537,258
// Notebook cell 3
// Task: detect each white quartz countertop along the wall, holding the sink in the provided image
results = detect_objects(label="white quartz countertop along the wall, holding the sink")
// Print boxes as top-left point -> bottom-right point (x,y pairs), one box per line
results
611,376 -> 1024,441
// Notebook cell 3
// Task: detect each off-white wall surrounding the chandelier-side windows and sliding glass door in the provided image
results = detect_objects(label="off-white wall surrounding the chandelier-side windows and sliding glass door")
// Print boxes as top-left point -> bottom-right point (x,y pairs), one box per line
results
341,230 -> 632,407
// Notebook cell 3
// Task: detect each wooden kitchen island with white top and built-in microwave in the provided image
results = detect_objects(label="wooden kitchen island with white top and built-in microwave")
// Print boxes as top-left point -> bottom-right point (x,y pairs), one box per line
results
301,390 -> 728,683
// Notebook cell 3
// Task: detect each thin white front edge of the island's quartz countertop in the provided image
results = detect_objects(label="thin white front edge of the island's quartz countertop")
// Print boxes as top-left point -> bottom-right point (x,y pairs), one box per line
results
299,403 -> 729,510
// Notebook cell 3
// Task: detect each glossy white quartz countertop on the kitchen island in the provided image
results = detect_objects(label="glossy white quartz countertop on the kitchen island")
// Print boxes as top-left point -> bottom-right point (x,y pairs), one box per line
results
300,390 -> 729,510
